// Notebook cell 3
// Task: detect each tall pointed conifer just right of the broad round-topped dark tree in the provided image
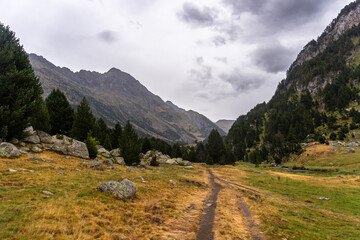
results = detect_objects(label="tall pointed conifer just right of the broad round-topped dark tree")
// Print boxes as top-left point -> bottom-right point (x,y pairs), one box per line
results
71,97 -> 95,141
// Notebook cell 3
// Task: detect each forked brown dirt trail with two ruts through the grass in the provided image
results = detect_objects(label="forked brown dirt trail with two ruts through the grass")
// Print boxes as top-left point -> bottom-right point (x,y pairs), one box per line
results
196,169 -> 263,240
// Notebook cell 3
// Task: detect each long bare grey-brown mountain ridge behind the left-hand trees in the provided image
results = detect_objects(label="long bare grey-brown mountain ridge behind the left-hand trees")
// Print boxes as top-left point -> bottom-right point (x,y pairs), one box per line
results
29,54 -> 225,143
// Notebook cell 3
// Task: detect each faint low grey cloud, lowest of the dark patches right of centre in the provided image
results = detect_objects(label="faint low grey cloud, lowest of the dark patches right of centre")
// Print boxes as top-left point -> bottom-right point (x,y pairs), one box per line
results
219,68 -> 265,93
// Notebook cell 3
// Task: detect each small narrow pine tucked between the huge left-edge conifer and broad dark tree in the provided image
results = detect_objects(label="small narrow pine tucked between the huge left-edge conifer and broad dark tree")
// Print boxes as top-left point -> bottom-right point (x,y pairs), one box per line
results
31,98 -> 51,132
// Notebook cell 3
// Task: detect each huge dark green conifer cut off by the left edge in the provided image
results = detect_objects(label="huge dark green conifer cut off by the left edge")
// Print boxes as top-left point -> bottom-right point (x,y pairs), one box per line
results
0,23 -> 42,139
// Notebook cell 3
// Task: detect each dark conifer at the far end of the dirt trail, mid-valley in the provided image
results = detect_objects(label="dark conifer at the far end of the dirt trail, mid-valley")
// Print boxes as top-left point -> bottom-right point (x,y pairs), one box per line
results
206,129 -> 225,163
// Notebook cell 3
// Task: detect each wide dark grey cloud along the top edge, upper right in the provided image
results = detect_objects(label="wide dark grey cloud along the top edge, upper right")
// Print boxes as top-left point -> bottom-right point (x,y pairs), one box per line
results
223,0 -> 332,31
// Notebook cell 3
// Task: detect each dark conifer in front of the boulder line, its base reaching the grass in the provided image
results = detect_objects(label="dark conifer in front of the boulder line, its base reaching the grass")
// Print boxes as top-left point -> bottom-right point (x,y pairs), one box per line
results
120,121 -> 141,165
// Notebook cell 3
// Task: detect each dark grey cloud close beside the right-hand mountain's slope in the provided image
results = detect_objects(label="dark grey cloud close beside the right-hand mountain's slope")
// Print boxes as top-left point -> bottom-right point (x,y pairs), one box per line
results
251,40 -> 296,73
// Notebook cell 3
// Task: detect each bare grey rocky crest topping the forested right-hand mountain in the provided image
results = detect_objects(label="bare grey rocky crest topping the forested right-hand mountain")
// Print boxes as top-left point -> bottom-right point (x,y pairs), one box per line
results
289,0 -> 360,72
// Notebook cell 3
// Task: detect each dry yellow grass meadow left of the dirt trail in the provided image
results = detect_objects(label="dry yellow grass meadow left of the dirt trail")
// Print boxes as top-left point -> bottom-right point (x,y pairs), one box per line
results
0,151 -> 208,239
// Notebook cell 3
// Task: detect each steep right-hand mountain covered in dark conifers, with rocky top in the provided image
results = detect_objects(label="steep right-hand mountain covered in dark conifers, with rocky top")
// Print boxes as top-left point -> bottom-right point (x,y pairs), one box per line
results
227,0 -> 360,164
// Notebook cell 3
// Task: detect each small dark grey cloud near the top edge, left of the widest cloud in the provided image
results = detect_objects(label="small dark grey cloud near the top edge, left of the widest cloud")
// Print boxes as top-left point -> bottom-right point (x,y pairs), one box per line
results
178,2 -> 216,27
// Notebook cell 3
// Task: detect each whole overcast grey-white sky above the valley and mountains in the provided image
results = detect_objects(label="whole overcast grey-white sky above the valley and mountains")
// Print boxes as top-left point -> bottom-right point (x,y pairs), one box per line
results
0,0 -> 352,121
